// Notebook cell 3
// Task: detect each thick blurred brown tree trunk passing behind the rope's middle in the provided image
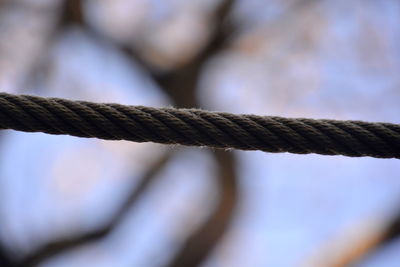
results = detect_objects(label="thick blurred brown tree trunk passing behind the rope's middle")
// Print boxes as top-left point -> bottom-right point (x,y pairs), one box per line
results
151,0 -> 237,267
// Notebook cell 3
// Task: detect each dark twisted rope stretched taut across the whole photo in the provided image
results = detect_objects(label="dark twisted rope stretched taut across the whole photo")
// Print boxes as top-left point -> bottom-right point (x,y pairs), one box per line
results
0,93 -> 400,158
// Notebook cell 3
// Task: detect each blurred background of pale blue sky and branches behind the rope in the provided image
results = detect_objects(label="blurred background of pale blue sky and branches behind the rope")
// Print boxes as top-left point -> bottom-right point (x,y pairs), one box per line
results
0,0 -> 400,267
